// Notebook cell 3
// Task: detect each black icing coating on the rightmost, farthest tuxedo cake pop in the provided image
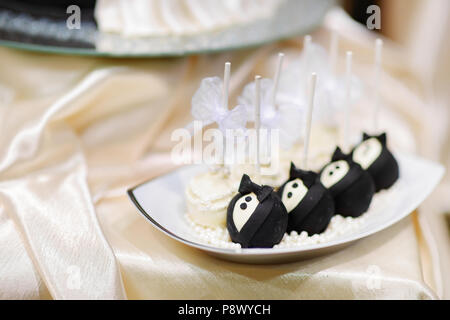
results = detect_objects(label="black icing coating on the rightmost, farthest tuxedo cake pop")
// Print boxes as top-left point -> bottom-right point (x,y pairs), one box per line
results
351,133 -> 399,192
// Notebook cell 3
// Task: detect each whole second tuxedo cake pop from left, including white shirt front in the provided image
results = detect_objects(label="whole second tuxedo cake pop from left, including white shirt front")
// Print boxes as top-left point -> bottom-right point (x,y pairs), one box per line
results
278,162 -> 334,235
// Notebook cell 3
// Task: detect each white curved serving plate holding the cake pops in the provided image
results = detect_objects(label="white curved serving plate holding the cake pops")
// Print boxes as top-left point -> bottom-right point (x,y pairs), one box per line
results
128,154 -> 445,264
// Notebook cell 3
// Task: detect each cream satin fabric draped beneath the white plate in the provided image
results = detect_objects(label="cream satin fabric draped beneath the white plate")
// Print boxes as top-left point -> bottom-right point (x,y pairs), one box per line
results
0,23 -> 442,299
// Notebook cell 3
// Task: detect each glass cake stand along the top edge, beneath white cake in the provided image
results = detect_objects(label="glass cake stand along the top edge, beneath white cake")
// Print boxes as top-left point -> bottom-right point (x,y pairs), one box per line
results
0,0 -> 335,57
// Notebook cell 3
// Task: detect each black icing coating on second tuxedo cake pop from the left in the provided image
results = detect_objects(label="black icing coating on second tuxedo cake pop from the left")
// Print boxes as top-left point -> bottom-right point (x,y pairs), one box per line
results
278,163 -> 334,235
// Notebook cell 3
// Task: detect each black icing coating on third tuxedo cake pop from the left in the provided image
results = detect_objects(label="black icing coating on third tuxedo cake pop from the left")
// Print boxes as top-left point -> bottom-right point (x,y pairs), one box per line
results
317,147 -> 375,217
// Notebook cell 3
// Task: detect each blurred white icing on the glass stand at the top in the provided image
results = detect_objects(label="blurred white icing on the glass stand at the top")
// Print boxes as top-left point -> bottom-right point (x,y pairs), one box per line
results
95,0 -> 283,37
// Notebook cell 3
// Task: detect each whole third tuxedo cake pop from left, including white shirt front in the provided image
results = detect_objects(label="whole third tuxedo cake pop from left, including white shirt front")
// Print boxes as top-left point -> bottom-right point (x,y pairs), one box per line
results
319,147 -> 375,217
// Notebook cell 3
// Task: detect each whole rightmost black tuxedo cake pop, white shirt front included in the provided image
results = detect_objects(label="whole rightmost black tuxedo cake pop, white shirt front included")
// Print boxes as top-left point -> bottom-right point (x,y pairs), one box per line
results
351,133 -> 399,192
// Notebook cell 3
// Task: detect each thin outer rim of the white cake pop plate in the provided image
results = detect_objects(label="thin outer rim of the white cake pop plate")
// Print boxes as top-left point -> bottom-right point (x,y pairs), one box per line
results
127,153 -> 445,258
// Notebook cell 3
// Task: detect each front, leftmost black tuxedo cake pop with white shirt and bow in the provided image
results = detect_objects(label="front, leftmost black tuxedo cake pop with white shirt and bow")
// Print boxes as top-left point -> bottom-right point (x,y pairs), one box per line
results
227,174 -> 288,248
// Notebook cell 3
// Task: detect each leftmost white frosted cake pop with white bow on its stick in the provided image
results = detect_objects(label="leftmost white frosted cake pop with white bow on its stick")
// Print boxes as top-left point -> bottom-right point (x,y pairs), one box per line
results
185,62 -> 247,227
